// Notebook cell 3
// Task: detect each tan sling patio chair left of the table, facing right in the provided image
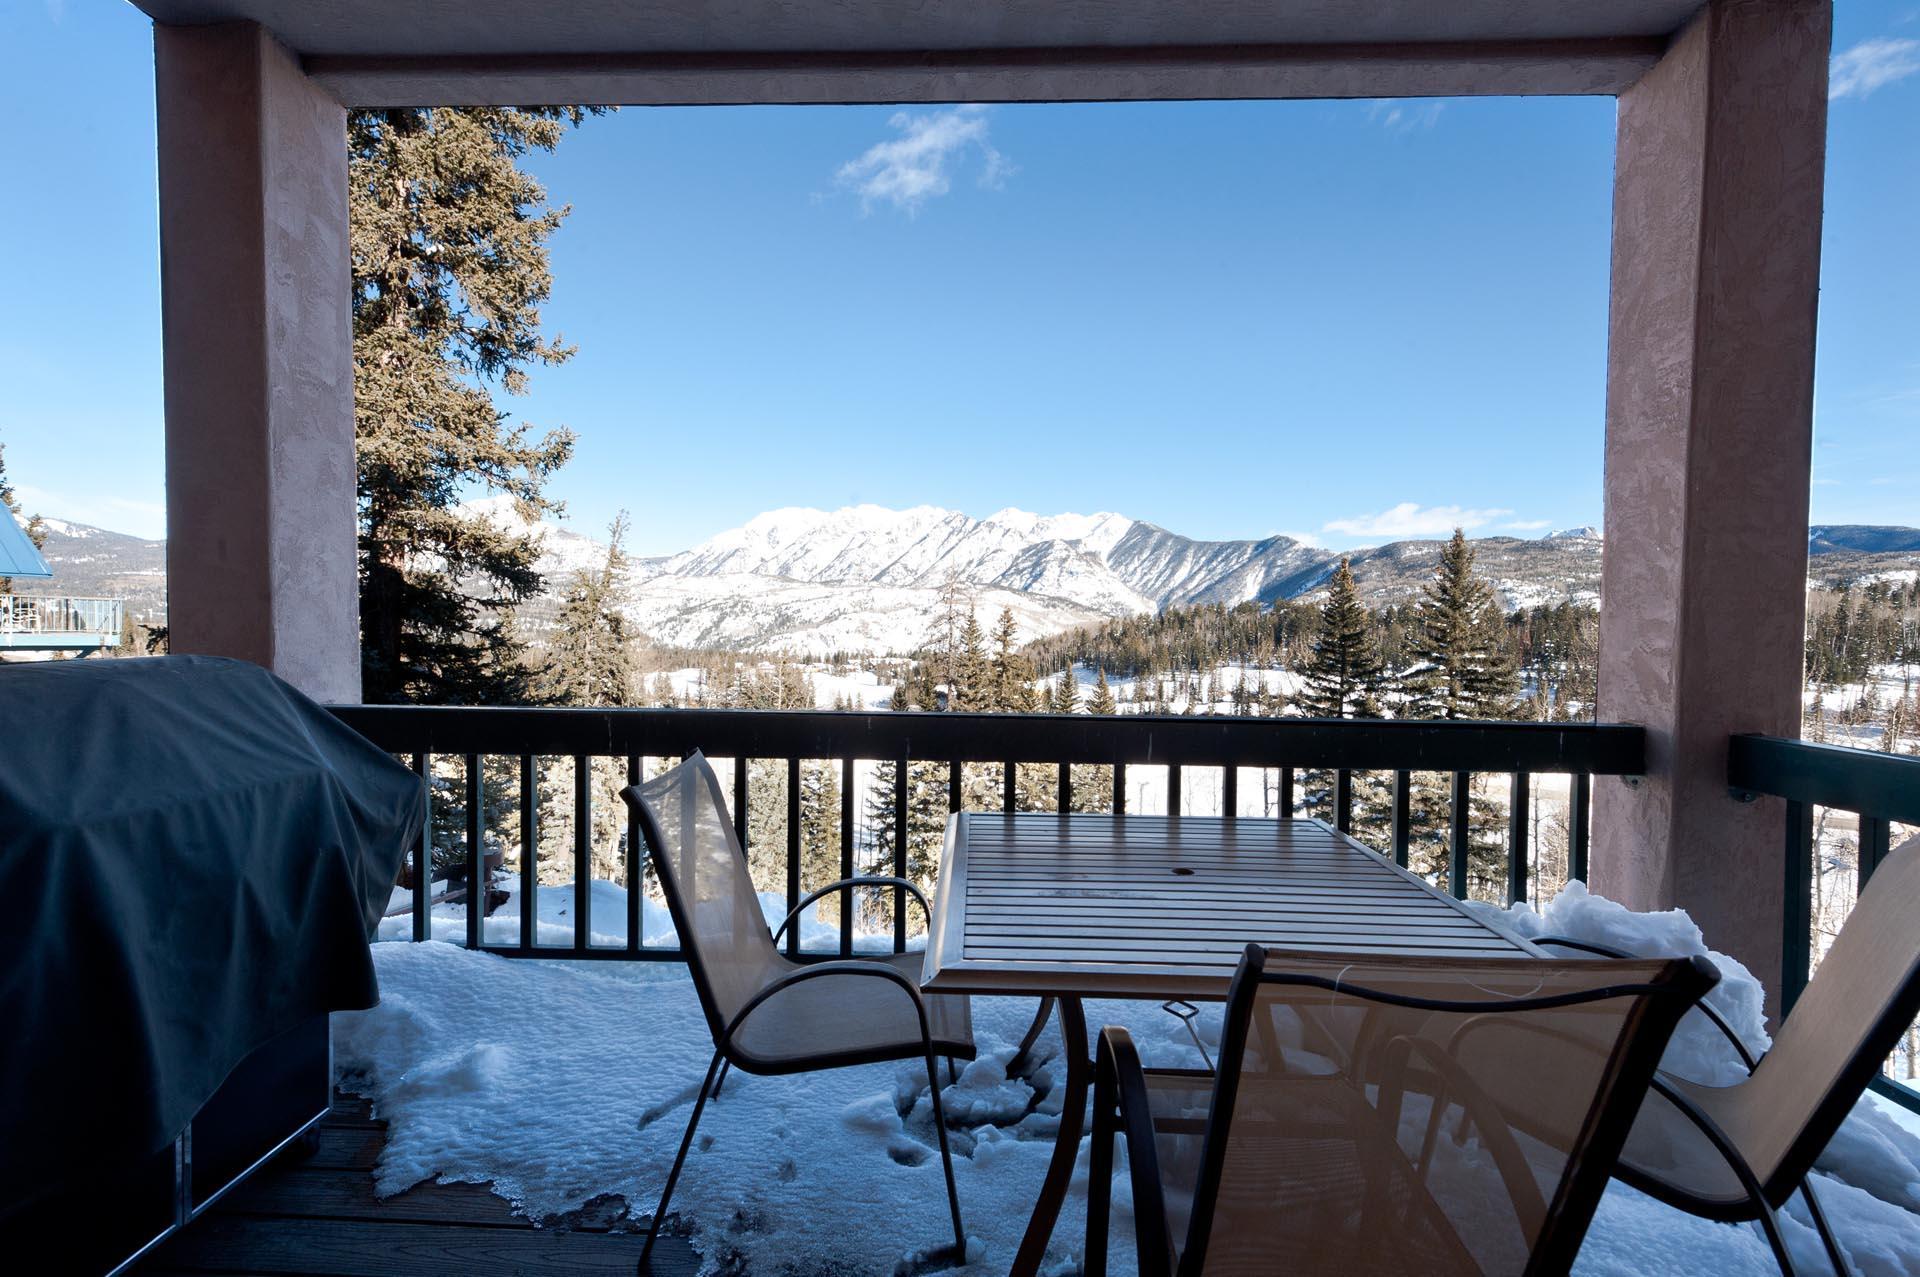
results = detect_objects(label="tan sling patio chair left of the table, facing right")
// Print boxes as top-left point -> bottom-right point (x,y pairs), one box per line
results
622,753 -> 973,1271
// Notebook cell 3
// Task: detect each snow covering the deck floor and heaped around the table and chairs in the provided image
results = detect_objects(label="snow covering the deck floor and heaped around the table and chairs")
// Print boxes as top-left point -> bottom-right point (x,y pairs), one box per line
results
334,883 -> 1920,1277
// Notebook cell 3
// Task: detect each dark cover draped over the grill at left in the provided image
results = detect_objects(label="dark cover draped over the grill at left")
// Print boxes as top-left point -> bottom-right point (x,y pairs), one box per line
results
0,657 -> 426,1217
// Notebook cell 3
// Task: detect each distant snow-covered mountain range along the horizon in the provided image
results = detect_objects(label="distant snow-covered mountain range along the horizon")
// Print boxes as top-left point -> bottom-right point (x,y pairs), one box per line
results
33,497 -> 1920,655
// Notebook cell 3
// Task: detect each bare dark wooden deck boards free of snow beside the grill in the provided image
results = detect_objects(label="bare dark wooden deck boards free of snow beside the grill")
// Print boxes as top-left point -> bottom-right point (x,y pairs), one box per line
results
132,1096 -> 699,1277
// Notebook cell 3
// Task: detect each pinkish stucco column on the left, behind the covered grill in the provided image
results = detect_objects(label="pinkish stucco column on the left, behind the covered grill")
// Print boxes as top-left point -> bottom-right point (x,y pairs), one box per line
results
154,23 -> 359,701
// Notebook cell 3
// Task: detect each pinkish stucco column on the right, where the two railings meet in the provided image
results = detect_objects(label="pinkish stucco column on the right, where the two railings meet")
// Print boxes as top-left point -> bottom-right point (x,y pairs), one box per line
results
1592,0 -> 1832,1013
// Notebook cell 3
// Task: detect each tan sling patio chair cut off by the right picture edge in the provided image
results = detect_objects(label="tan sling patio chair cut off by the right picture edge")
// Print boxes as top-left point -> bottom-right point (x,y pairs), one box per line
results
1534,839 -> 1920,1275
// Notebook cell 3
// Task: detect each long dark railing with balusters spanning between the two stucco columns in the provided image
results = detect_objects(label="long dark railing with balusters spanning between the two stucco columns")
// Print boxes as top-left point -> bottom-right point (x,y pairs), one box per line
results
334,705 -> 1645,960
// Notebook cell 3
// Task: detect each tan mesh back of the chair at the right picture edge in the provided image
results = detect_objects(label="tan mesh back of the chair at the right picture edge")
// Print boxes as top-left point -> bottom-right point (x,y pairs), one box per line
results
1715,839 -> 1920,1196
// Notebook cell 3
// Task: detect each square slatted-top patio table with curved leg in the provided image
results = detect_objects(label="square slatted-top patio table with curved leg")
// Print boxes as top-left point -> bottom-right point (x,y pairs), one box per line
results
922,812 -> 1544,1277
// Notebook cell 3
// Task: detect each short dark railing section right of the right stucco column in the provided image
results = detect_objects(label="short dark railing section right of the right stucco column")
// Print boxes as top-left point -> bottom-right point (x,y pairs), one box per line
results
1726,735 -> 1920,1110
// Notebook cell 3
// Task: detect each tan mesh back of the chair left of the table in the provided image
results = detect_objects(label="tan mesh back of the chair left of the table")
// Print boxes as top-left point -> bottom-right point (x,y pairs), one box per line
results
622,753 -> 787,1041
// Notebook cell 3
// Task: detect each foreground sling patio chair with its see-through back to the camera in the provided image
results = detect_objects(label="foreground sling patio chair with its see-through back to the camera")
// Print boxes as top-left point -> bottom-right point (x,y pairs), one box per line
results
1085,945 -> 1718,1277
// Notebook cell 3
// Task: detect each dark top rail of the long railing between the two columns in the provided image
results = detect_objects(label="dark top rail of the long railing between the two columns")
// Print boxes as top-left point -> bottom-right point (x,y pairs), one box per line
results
334,705 -> 1645,776
